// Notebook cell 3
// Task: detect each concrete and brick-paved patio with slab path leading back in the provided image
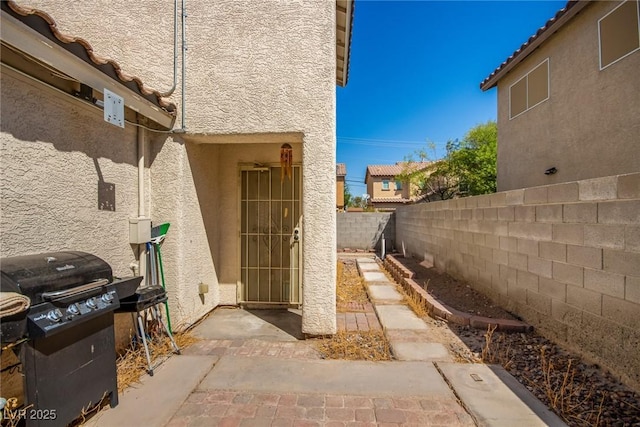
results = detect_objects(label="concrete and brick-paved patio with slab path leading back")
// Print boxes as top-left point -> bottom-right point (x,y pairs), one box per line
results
87,257 -> 563,427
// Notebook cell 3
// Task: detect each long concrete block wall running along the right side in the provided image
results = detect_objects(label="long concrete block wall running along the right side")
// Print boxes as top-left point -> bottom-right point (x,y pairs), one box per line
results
395,173 -> 640,389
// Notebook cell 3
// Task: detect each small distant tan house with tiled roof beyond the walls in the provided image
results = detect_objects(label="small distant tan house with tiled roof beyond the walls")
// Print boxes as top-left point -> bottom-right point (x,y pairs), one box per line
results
364,162 -> 430,211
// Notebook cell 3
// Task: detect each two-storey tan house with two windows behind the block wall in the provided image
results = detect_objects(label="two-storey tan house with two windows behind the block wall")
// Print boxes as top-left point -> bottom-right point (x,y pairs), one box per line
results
480,0 -> 640,191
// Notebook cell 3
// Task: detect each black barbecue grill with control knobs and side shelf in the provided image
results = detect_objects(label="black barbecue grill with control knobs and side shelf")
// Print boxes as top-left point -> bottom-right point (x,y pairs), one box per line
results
0,252 -> 142,426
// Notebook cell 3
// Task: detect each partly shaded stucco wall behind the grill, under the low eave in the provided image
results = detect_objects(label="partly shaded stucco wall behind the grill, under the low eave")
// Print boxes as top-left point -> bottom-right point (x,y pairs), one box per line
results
0,69 -> 138,345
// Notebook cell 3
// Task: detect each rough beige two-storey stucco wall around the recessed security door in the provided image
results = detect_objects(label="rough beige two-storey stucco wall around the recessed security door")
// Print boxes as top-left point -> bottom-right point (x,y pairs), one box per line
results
11,0 -> 336,335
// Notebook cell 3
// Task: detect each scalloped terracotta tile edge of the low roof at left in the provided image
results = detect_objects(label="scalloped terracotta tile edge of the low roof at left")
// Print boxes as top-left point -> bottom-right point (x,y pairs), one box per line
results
2,0 -> 177,116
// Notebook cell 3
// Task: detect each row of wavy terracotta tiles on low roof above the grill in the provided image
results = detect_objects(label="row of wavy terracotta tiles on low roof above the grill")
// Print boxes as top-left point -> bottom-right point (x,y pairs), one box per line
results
2,0 -> 176,115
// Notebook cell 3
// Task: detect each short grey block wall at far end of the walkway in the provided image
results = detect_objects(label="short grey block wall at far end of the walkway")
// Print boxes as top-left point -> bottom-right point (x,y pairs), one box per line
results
336,212 -> 396,252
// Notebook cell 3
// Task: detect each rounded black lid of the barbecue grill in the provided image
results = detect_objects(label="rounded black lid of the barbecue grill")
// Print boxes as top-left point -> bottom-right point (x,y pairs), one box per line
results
0,251 -> 113,305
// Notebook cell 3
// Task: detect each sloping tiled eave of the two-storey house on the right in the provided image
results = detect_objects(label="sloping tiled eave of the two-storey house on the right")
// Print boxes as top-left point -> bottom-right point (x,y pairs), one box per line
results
480,0 -> 590,91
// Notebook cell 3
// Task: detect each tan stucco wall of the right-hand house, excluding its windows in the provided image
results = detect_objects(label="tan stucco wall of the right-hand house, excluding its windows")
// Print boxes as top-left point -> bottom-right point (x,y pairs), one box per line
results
498,1 -> 640,191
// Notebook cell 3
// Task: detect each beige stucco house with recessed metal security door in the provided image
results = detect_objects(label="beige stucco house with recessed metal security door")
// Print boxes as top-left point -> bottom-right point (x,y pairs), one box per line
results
0,0 -> 353,335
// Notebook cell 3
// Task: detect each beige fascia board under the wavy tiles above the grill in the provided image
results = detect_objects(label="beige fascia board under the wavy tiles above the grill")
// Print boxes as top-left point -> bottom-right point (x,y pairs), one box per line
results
1,11 -> 175,129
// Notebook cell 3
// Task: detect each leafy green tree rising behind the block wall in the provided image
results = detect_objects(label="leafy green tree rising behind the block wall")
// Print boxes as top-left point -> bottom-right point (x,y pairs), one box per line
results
400,121 -> 498,201
